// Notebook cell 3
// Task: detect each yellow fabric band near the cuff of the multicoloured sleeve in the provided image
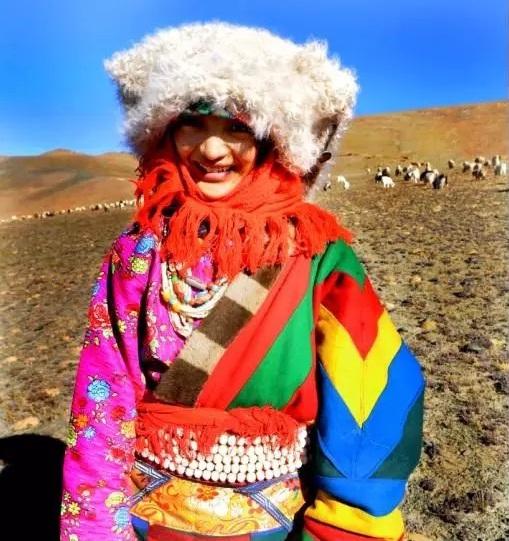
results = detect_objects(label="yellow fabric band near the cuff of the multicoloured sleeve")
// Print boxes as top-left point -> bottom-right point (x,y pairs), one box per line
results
306,490 -> 404,541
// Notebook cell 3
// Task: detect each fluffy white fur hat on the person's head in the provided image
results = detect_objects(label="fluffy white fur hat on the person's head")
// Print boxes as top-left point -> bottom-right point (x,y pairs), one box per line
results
104,22 -> 358,174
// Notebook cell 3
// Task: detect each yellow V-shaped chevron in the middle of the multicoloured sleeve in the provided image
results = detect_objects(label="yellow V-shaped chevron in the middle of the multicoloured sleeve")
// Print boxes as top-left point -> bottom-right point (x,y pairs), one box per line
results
317,306 -> 401,426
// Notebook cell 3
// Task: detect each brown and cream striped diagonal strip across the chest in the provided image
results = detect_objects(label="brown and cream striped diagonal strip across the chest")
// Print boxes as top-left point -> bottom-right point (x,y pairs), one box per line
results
154,266 -> 281,406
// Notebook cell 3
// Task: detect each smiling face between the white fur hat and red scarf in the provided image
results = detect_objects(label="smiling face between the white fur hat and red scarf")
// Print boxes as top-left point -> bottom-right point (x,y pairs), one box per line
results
173,114 -> 258,200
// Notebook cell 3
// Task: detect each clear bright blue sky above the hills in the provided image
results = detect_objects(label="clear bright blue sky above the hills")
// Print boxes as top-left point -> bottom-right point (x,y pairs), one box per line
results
0,0 -> 508,155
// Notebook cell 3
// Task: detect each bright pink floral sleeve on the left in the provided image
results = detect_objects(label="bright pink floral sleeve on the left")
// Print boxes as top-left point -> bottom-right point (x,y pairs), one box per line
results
61,225 -> 155,541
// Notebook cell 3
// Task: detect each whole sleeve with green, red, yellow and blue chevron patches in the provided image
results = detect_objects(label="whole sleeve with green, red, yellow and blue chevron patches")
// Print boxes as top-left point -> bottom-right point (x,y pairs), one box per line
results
302,242 -> 425,541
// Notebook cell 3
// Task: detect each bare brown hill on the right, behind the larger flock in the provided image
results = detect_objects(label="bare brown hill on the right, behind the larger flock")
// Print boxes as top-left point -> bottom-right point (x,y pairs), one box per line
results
338,101 -> 509,173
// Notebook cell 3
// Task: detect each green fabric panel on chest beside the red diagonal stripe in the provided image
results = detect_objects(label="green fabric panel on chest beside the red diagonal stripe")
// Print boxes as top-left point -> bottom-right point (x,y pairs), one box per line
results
228,258 -> 320,409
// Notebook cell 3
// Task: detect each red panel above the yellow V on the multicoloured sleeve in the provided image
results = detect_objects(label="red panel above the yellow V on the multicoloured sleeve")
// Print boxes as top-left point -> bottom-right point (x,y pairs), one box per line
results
322,273 -> 384,358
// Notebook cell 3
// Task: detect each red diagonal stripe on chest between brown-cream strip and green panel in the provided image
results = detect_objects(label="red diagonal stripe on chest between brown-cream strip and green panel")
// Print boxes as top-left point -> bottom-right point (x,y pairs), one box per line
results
196,256 -> 311,409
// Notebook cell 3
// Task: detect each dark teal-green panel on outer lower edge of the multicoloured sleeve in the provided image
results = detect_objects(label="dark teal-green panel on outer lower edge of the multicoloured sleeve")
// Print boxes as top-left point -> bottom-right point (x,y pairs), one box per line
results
371,390 -> 424,479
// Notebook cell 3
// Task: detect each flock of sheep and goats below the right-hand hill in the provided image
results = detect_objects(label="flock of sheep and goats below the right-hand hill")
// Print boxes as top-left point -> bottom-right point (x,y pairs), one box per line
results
324,154 -> 507,191
